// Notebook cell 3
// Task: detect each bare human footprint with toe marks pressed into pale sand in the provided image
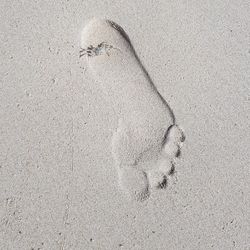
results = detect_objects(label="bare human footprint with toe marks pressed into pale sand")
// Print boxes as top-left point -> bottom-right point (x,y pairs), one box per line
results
80,19 -> 184,201
